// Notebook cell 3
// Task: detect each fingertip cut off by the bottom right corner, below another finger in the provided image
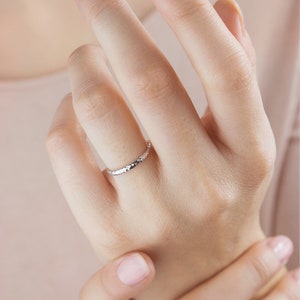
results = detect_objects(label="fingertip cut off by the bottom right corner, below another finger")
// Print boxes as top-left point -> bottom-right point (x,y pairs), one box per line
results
264,269 -> 300,300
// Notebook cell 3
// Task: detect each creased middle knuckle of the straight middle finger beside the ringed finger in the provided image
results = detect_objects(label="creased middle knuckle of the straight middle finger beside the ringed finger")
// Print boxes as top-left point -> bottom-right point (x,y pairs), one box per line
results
133,64 -> 178,101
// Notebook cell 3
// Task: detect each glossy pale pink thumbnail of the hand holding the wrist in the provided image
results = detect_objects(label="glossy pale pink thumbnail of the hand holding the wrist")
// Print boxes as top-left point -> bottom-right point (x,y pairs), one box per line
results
118,254 -> 150,286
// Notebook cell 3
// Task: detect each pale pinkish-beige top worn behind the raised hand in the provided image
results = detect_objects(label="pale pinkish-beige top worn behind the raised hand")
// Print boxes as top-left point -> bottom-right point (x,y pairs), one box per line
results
0,0 -> 300,300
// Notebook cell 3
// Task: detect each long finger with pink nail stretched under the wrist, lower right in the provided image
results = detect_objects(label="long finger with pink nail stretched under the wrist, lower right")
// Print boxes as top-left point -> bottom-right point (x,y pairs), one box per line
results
180,237 -> 293,300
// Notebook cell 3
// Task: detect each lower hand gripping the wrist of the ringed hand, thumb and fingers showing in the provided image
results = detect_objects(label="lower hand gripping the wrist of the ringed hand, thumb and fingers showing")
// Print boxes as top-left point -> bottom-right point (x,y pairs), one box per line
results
80,237 -> 300,300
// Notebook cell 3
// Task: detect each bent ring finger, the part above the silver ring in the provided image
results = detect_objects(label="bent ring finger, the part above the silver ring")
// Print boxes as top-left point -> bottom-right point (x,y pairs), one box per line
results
69,45 -> 155,178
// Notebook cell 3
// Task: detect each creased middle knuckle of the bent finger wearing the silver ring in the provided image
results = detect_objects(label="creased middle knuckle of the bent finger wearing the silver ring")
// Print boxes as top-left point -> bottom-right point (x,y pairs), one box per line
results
74,84 -> 116,122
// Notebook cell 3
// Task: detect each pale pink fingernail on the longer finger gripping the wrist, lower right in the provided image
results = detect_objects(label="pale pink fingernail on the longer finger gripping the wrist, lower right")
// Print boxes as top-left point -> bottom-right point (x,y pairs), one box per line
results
268,236 -> 293,264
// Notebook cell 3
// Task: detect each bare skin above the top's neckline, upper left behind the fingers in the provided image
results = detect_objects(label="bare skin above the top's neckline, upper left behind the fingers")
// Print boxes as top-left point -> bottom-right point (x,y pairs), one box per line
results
0,0 -> 153,80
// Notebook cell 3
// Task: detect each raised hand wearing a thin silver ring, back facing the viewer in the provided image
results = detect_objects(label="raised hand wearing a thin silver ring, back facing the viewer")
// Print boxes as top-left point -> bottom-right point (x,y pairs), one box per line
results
47,0 -> 275,299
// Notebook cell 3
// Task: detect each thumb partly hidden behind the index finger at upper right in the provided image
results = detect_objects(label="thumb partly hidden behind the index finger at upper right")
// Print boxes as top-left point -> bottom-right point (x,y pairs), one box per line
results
214,0 -> 256,66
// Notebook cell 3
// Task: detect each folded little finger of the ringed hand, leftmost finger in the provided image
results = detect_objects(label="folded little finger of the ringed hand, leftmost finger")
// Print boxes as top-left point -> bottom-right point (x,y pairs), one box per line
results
47,95 -> 115,240
